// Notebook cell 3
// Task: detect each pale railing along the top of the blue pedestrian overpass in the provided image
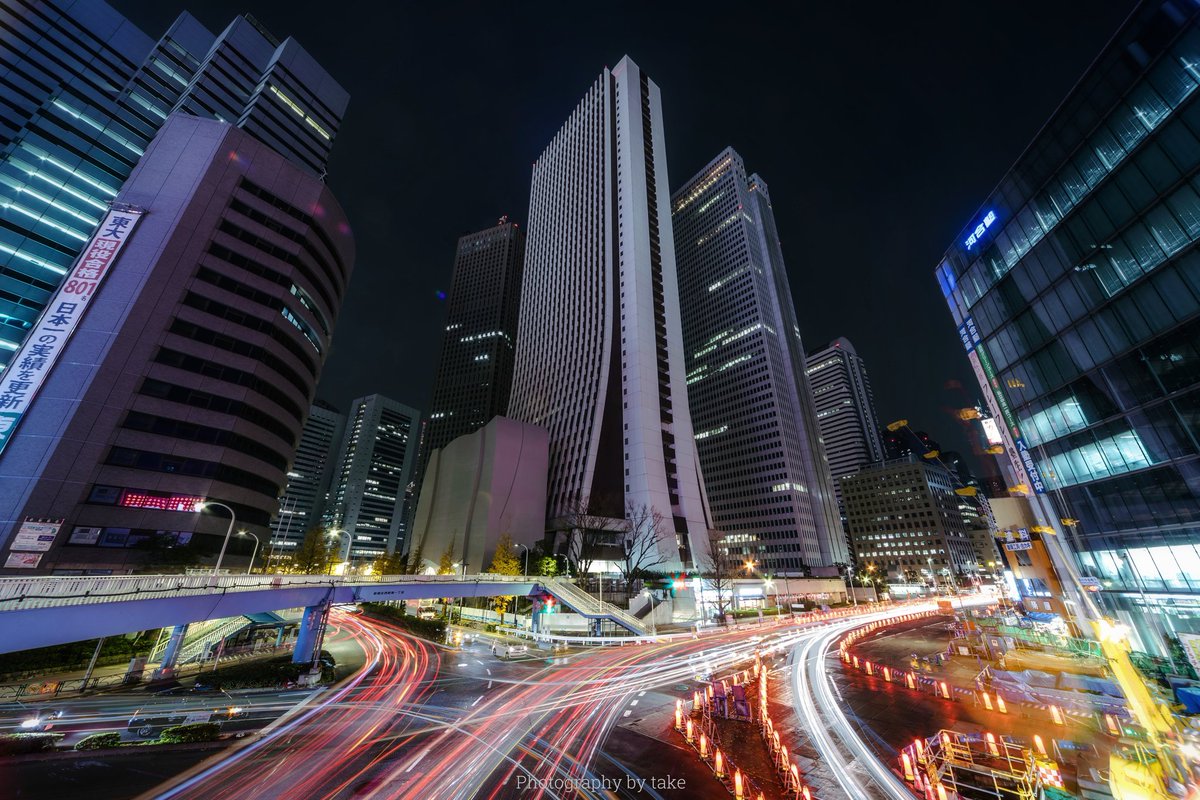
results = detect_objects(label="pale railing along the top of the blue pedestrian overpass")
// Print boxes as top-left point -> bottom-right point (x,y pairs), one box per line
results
0,573 -> 540,612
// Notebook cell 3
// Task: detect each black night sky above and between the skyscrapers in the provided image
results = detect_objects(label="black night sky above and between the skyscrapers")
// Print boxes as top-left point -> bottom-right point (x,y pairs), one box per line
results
113,0 -> 1133,479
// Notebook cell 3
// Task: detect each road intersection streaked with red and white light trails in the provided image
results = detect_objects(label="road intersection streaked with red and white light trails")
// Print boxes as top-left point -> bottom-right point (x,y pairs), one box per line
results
4,609 -> 945,800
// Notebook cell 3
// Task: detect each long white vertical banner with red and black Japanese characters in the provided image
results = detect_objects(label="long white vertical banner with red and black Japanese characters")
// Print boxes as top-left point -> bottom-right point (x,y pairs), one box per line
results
0,209 -> 142,452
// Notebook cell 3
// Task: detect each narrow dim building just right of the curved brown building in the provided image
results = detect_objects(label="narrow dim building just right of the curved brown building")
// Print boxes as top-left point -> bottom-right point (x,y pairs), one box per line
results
268,399 -> 346,564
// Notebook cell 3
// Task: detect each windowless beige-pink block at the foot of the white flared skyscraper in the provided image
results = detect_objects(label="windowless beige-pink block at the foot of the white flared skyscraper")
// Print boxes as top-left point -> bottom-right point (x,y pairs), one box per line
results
408,416 -> 550,575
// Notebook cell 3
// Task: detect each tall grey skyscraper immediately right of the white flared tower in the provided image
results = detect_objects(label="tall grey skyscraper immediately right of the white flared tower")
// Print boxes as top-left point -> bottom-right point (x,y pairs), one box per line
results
672,149 -> 848,571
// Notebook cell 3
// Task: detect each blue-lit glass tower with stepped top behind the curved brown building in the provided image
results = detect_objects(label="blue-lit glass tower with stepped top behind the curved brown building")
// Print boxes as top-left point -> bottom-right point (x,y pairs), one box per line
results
0,0 -> 349,368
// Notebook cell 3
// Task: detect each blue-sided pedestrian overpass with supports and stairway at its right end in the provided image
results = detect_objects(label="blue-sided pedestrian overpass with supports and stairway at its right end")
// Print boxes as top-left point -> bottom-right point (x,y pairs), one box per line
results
0,573 -> 647,666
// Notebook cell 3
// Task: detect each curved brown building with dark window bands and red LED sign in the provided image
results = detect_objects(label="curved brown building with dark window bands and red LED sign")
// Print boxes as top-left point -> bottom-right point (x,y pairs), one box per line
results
0,114 -> 354,572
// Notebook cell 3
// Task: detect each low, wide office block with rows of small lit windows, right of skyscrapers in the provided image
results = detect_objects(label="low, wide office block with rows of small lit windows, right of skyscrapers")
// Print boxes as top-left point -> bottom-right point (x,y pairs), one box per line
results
841,456 -> 978,584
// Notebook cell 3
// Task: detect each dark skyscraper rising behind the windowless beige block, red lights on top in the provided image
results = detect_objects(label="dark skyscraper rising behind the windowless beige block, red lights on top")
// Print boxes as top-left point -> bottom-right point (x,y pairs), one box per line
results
418,217 -> 524,475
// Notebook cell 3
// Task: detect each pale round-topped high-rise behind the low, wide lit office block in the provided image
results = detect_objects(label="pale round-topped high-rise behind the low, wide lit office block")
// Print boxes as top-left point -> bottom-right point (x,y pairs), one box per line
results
805,337 -> 883,513
